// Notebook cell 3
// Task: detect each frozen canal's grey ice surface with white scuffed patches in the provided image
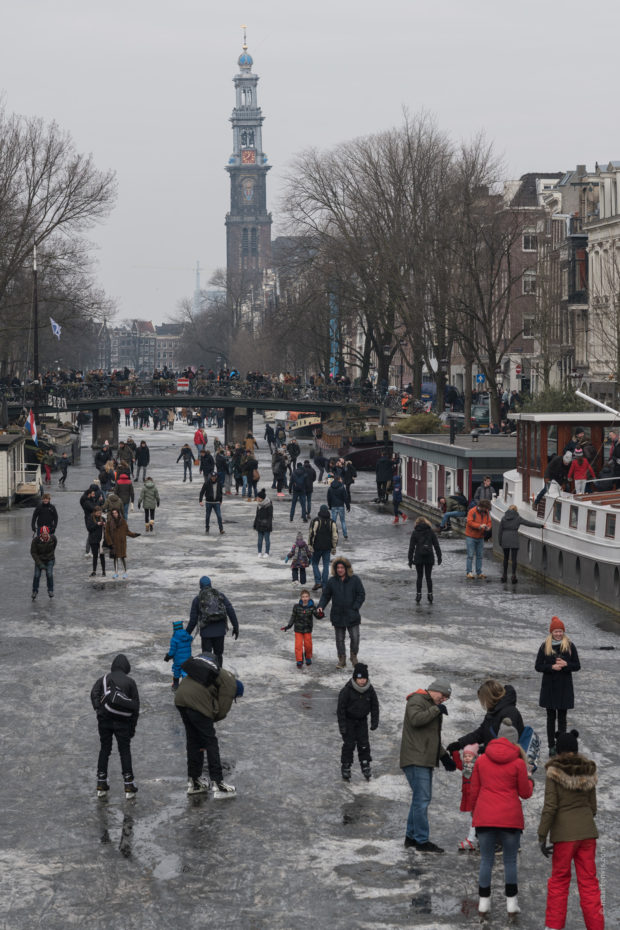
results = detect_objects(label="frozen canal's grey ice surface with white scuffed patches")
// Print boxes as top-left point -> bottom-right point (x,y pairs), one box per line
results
0,418 -> 620,930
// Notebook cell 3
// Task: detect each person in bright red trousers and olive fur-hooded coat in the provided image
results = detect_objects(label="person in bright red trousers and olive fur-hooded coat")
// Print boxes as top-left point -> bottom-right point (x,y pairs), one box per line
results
538,730 -> 605,930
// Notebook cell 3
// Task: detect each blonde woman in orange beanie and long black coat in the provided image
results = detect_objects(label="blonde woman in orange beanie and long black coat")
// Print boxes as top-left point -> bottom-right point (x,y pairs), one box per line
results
535,617 -> 581,756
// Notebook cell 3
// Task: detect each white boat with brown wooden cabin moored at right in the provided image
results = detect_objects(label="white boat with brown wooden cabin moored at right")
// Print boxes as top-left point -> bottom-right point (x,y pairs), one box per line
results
491,410 -> 620,616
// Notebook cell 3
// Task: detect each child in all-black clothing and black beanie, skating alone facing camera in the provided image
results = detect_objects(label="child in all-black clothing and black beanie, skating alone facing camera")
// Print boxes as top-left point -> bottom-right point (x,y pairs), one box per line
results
338,662 -> 379,781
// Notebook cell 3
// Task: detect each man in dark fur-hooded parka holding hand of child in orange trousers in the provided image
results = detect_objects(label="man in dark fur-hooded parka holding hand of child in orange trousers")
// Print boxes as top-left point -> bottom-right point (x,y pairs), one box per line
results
319,556 -> 366,668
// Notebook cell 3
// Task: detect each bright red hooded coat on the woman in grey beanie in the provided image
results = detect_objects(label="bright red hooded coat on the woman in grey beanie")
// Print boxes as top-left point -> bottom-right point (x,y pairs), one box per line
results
471,736 -> 534,830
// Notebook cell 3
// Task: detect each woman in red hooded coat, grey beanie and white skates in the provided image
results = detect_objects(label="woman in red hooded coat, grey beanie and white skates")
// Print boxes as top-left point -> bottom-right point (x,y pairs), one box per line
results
471,717 -> 534,914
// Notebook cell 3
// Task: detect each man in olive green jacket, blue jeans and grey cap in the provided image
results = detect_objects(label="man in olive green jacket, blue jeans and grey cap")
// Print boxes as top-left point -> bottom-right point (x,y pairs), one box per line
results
400,678 -> 456,853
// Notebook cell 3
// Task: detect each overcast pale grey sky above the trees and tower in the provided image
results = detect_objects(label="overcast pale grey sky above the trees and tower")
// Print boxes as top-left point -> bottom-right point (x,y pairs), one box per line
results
1,0 -> 620,322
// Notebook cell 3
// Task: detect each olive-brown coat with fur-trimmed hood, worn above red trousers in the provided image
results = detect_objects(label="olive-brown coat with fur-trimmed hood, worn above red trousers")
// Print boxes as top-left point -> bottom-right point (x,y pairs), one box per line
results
538,752 -> 598,843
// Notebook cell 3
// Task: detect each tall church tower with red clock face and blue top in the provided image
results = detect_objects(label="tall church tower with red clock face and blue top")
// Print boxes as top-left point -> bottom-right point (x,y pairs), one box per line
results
226,27 -> 271,284
